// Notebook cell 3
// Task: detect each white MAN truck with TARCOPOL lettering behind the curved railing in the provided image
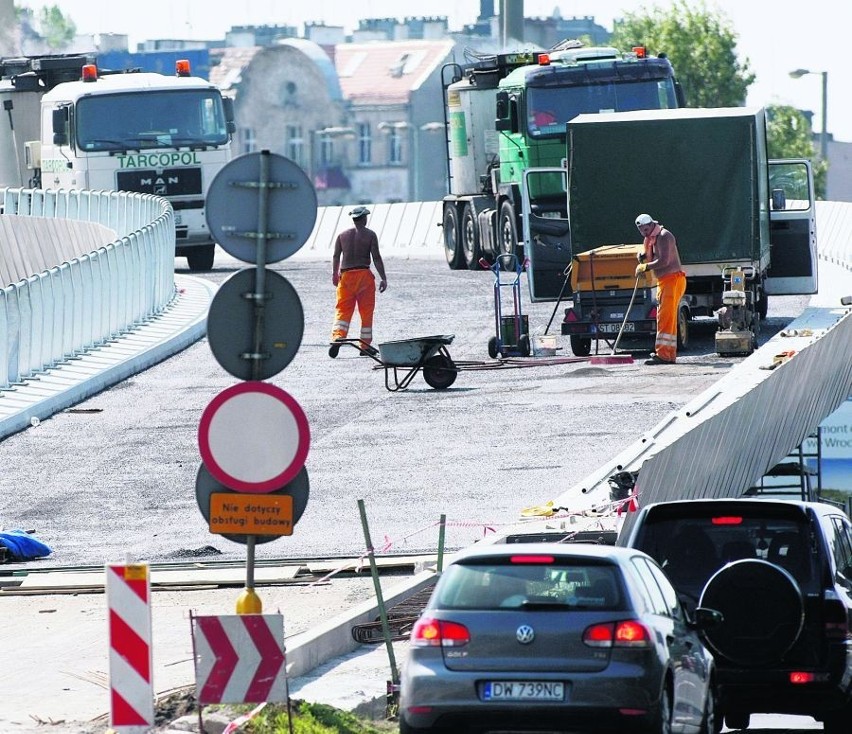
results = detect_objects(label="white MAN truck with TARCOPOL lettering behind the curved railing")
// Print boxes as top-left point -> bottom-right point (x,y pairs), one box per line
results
0,54 -> 235,270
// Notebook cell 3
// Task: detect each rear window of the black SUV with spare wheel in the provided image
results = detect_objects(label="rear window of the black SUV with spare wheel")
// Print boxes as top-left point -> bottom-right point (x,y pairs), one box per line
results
634,505 -> 816,587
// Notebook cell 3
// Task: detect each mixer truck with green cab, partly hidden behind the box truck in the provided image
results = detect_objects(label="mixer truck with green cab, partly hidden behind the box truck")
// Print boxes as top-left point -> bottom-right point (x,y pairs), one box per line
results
442,41 -> 683,270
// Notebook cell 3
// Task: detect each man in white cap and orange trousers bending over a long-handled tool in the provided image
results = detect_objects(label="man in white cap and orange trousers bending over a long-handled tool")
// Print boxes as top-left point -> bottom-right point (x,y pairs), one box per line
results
636,214 -> 686,365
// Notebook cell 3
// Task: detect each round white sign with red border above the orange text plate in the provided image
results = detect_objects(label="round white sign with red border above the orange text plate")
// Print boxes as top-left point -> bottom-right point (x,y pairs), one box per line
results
198,381 -> 310,493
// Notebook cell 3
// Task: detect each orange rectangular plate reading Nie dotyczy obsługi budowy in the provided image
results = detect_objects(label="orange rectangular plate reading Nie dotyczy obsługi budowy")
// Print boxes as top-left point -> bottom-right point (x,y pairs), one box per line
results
210,492 -> 293,535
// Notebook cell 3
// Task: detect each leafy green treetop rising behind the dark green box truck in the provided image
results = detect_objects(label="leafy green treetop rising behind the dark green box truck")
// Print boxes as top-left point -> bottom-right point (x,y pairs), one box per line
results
611,0 -> 755,107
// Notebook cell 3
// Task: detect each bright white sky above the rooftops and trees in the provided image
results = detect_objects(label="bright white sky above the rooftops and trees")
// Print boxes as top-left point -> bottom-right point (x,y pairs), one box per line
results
20,0 -> 852,142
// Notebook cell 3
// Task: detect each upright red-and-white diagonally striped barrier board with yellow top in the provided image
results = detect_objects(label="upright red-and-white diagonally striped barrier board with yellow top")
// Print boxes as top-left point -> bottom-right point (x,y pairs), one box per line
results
106,564 -> 154,734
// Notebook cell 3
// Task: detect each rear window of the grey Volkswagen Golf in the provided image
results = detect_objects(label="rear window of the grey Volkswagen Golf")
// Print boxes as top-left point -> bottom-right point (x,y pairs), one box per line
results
430,556 -> 623,611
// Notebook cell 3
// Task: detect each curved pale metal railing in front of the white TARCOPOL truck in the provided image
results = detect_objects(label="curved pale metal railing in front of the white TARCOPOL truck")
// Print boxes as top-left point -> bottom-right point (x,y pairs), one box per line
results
0,188 -> 175,390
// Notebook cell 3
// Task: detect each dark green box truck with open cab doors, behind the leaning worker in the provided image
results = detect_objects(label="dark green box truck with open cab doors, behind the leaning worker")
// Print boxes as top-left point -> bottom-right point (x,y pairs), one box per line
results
523,107 -> 817,354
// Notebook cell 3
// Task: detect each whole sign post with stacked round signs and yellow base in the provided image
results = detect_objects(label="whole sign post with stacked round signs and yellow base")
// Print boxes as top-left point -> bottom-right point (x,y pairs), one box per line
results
201,150 -> 317,614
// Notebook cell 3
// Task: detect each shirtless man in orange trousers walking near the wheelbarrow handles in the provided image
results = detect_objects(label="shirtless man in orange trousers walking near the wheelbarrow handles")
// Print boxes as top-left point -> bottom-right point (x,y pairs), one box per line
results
328,206 -> 388,357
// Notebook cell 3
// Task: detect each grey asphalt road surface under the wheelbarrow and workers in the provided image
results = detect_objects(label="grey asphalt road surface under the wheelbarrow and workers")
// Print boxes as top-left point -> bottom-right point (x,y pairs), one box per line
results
0,253 -> 806,567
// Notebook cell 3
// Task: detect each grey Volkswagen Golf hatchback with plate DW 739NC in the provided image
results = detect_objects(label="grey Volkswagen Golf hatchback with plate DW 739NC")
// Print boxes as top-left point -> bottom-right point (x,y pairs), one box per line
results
399,543 -> 721,734
